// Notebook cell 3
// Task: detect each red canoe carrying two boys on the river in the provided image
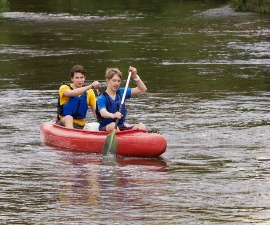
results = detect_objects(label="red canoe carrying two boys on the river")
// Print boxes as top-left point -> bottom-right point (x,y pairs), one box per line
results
40,122 -> 167,157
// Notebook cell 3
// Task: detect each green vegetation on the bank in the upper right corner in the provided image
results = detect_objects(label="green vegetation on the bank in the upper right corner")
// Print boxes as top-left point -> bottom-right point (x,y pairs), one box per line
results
230,0 -> 270,13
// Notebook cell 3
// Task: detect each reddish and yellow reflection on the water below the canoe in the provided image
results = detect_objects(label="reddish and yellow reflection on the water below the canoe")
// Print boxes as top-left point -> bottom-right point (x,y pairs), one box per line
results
55,152 -> 168,220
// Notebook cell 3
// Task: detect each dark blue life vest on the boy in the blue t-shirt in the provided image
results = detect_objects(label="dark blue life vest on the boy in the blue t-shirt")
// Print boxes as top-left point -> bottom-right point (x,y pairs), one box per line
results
96,90 -> 127,127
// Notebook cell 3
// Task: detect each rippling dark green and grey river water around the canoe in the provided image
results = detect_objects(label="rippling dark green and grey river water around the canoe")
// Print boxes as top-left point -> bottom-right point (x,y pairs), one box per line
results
0,0 -> 270,224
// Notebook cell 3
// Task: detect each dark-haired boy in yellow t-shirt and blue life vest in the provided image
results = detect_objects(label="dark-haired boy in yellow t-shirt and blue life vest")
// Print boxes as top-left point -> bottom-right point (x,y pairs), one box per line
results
56,65 -> 100,129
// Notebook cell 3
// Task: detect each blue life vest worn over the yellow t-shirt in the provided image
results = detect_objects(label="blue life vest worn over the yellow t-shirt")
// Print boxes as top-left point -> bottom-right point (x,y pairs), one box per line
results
57,85 -> 88,119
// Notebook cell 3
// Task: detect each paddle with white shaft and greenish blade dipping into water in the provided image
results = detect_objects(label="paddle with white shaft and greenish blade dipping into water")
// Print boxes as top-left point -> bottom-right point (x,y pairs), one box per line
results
102,71 -> 131,156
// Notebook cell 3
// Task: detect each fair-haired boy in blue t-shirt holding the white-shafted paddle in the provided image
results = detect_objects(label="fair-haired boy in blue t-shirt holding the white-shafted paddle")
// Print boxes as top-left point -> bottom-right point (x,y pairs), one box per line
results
96,67 -> 147,132
